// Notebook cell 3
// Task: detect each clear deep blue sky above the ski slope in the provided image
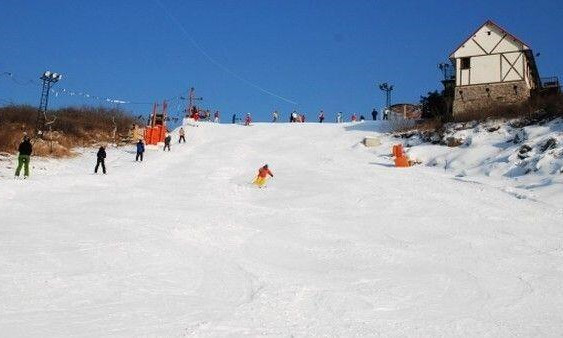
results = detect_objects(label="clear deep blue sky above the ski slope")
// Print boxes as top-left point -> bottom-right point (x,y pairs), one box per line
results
0,0 -> 563,120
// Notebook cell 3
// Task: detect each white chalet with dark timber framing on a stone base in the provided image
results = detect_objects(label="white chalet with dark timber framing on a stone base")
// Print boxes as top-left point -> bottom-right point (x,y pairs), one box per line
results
450,21 -> 541,115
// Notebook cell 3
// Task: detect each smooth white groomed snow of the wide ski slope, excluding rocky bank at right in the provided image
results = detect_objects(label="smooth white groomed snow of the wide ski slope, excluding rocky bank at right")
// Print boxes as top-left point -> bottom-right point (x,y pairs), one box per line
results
0,123 -> 563,337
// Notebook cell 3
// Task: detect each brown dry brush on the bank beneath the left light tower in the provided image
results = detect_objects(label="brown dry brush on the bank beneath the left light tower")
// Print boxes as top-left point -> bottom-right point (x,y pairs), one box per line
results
0,106 -> 134,157
